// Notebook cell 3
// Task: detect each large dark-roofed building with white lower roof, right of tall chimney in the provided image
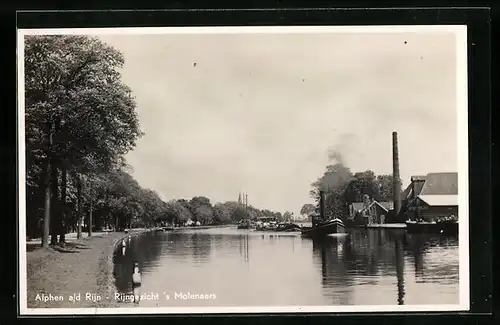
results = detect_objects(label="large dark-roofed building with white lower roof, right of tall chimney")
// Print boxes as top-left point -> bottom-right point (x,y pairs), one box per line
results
402,173 -> 458,221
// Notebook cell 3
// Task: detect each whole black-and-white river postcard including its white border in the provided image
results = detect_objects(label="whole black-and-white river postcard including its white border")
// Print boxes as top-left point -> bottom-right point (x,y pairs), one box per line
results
17,25 -> 470,315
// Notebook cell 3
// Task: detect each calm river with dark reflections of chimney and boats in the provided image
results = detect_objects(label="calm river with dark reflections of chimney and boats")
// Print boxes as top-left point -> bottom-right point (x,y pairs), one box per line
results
114,227 -> 459,307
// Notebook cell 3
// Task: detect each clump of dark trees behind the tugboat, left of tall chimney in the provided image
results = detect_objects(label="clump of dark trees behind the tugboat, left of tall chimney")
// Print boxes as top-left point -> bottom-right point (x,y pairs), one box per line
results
300,163 -> 401,219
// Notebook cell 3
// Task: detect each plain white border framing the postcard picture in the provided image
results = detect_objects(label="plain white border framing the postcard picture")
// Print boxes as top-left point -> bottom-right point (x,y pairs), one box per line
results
17,25 -> 470,316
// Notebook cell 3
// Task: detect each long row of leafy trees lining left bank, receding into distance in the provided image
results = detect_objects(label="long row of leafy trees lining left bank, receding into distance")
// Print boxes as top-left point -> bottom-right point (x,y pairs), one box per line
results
24,35 -> 290,246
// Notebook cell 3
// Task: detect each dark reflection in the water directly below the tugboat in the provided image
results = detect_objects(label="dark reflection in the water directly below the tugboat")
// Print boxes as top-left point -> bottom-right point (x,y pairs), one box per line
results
313,236 -> 351,305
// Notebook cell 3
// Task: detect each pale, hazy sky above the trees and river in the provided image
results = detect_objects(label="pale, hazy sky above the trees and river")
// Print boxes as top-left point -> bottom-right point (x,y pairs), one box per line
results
95,32 -> 457,215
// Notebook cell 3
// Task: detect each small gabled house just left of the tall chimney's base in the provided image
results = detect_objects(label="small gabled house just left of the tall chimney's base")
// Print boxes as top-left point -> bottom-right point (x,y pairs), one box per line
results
349,198 -> 394,225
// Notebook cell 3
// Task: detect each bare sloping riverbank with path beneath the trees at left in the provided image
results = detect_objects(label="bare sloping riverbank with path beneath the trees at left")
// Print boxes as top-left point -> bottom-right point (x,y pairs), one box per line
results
26,229 -> 147,308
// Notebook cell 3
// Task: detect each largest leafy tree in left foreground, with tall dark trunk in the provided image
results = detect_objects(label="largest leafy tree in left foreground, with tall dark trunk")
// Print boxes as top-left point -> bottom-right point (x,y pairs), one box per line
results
25,35 -> 142,246
